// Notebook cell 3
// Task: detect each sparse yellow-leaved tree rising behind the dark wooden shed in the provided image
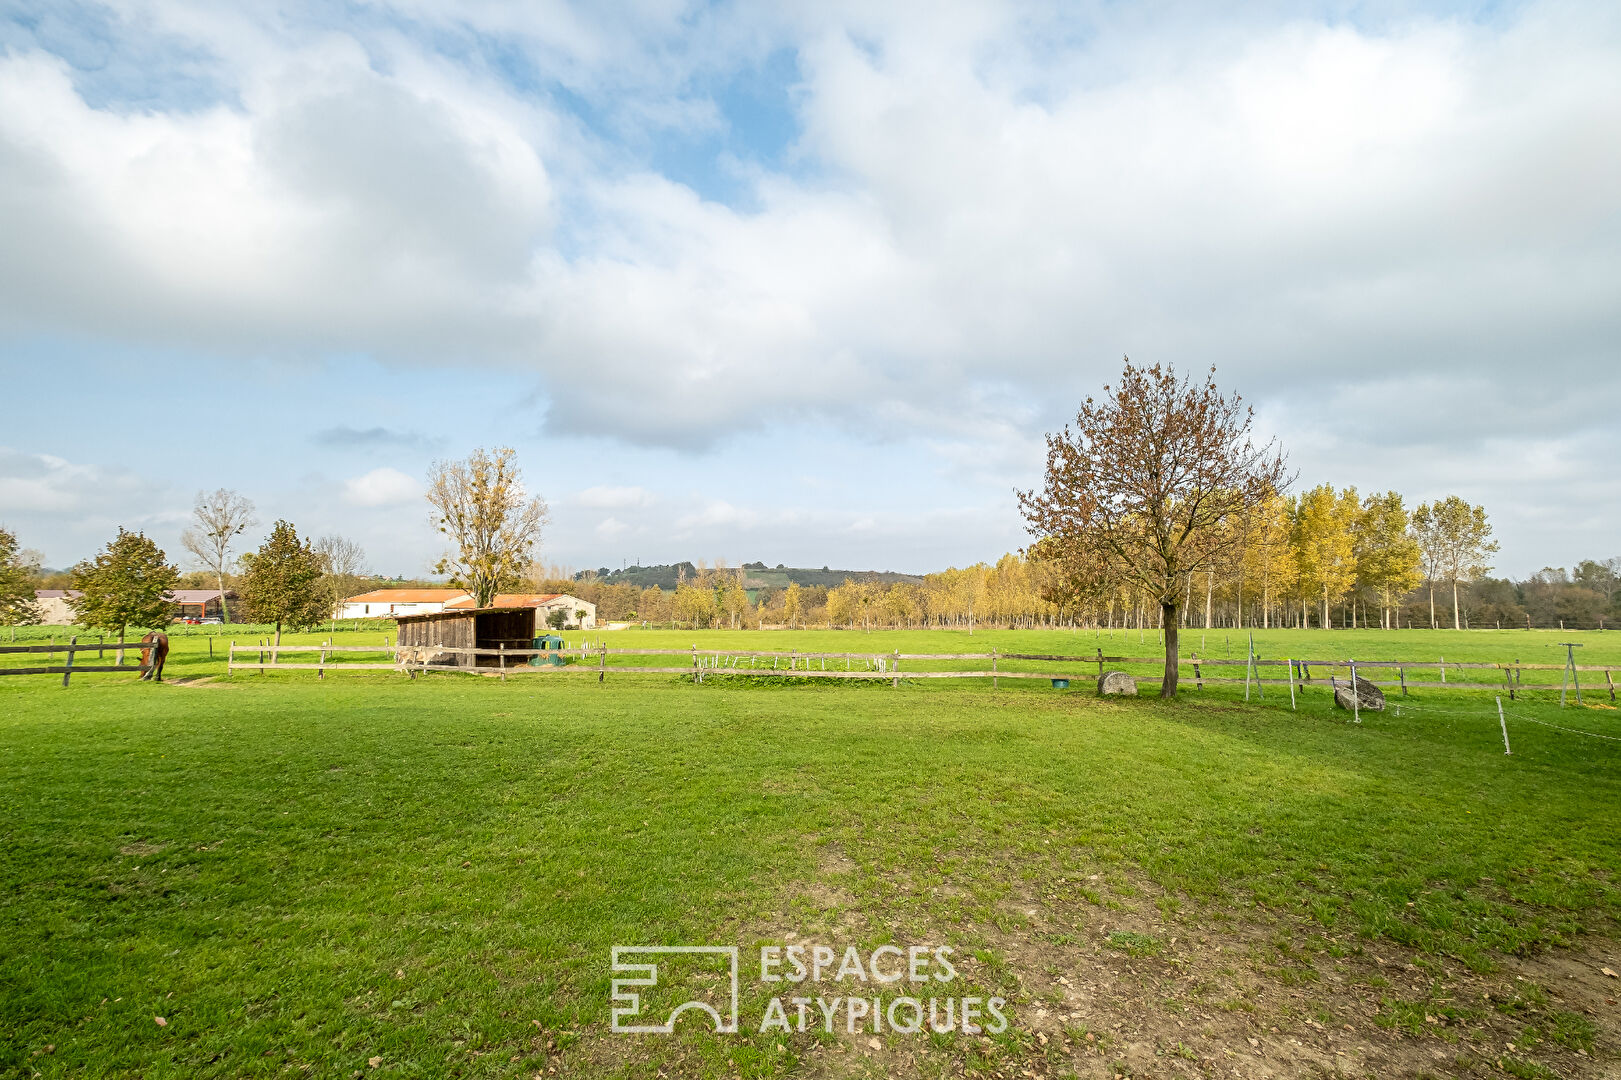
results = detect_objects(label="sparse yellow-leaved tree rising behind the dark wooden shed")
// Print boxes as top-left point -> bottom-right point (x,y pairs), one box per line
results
428,448 -> 546,608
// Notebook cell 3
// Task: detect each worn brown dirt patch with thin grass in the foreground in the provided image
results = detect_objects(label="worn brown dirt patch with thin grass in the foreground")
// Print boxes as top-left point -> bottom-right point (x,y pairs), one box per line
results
556,846 -> 1621,1080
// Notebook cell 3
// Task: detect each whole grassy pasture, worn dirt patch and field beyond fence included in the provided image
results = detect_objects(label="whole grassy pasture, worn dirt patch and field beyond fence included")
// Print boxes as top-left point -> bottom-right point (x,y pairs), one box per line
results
0,628 -> 1621,1077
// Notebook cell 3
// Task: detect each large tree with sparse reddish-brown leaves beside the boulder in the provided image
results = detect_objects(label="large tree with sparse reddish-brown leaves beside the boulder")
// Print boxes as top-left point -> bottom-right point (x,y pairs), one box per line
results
1018,358 -> 1287,697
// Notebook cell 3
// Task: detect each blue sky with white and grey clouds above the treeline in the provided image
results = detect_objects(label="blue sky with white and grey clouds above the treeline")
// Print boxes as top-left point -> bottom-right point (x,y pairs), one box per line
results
0,0 -> 1621,576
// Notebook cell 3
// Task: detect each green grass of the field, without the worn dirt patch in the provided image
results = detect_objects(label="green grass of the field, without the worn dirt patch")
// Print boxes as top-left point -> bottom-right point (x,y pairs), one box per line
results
0,631 -> 1621,1077
